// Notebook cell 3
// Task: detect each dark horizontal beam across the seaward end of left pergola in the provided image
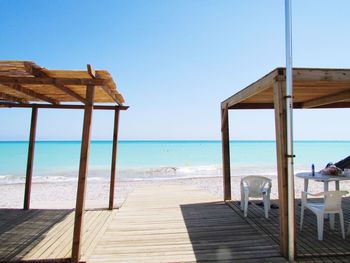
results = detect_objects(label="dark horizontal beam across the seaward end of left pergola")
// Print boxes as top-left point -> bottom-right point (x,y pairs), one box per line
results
0,101 -> 129,110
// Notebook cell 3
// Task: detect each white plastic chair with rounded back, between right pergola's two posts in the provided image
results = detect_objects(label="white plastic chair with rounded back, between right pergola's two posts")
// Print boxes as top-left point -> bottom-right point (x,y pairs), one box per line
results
241,175 -> 272,218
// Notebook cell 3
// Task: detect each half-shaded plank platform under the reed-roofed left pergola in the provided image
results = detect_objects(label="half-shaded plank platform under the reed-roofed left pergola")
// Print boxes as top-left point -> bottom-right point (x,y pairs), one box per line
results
0,209 -> 116,262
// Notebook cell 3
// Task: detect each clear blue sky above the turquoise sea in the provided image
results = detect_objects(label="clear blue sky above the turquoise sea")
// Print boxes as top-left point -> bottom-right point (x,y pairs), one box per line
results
0,0 -> 350,140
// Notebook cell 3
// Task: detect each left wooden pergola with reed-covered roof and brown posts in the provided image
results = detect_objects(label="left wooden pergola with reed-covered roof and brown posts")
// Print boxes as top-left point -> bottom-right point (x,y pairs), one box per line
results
0,61 -> 128,262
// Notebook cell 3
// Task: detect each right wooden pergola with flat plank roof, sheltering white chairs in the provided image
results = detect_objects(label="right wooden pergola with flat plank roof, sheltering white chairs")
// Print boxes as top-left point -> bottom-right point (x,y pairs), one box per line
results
221,68 -> 350,258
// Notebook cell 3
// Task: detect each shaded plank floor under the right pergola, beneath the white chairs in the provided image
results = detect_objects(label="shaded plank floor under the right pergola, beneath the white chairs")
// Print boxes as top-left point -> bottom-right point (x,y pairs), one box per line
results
228,198 -> 350,262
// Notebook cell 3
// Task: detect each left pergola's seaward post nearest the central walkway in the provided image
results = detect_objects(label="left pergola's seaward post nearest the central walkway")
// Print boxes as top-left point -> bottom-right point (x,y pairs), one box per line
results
108,107 -> 119,210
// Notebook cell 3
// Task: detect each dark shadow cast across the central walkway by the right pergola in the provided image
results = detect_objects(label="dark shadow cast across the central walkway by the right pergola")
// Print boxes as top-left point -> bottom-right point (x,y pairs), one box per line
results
181,202 -> 286,262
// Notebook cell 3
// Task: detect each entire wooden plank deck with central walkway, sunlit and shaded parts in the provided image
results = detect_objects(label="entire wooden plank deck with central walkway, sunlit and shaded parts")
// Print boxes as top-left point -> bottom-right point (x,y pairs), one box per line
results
0,184 -> 350,262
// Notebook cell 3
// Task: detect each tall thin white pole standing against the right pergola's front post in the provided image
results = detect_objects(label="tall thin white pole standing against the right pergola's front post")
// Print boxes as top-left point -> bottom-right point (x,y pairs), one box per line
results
285,0 -> 295,262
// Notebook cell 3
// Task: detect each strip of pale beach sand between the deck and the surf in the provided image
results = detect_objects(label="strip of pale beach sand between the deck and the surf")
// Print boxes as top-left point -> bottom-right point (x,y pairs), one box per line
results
0,176 -> 350,209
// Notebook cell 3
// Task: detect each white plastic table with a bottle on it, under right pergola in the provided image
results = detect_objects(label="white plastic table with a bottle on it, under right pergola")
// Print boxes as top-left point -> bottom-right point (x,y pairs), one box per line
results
295,172 -> 350,192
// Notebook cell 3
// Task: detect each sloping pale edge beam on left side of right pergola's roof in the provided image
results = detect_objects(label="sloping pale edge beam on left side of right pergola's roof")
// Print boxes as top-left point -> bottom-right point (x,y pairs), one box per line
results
221,68 -> 283,109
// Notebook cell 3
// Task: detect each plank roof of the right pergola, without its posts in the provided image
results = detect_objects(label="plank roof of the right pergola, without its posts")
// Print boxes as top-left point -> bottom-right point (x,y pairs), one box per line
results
221,68 -> 350,109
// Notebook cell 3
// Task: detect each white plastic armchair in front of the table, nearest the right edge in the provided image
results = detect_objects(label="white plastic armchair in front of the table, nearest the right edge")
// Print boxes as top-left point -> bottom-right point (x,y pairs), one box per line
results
300,191 -> 348,240
